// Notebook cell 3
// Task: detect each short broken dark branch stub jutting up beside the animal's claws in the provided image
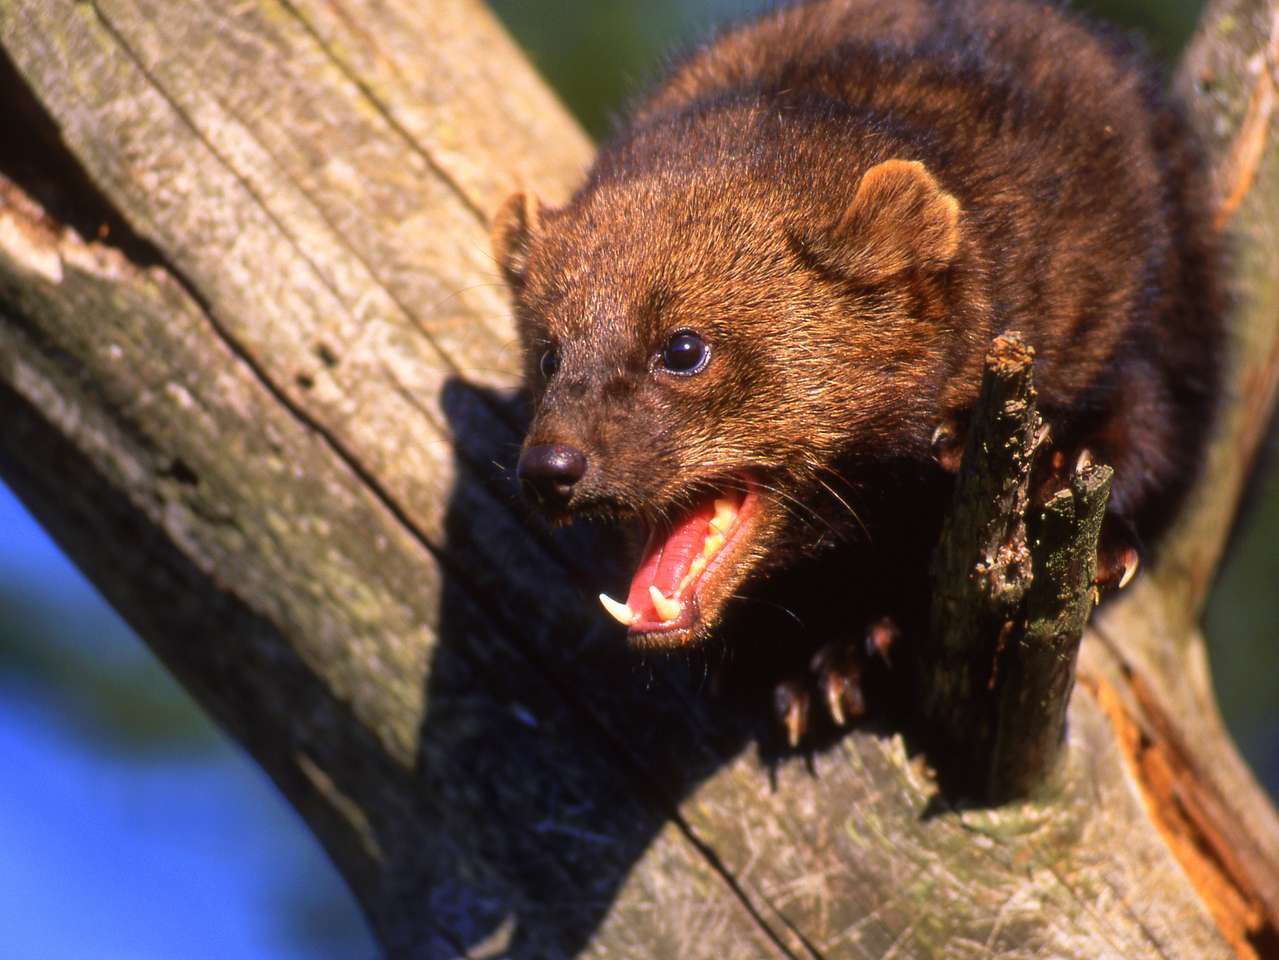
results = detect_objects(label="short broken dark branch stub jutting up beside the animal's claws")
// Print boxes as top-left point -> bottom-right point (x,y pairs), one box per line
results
914,332 -> 1111,803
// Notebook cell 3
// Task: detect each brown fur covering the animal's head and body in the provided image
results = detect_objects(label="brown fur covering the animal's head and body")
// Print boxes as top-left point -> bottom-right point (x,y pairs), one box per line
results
494,0 -> 1219,654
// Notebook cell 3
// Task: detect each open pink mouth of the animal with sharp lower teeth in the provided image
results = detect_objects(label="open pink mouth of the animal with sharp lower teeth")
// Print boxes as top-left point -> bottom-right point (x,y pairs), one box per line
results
600,478 -> 758,647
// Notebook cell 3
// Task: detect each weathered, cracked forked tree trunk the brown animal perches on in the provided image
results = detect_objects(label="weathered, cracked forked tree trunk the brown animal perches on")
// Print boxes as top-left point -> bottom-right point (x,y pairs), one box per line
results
0,0 -> 1279,957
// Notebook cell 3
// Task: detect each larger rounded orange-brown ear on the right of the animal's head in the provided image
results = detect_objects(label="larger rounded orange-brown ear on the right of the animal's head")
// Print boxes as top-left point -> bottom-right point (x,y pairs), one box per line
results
801,160 -> 959,284
